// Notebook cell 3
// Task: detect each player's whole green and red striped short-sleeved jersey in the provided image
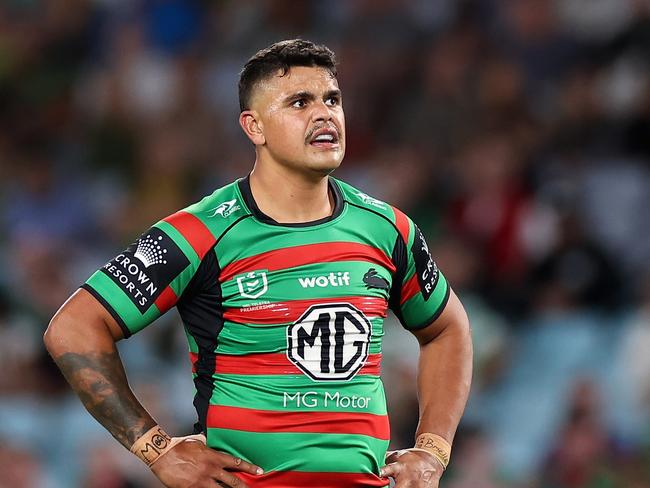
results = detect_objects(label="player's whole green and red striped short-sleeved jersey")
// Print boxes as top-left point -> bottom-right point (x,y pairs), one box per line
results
83,178 -> 449,487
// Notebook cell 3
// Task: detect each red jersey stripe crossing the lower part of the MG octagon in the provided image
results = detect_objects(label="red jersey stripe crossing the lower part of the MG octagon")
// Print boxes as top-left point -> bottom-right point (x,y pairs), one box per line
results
190,352 -> 381,376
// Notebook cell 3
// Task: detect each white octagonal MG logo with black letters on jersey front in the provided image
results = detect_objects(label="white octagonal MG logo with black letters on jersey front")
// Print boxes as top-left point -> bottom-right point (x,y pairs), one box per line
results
287,303 -> 372,381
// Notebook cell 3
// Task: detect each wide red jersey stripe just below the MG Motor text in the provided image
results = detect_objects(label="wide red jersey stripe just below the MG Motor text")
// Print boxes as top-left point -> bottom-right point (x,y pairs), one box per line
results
207,404 -> 390,440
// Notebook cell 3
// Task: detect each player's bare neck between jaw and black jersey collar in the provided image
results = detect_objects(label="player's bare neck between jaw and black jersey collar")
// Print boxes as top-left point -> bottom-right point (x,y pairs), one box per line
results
250,162 -> 334,224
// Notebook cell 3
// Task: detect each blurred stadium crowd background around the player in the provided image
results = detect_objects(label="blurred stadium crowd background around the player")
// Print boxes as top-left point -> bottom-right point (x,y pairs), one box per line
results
0,0 -> 650,488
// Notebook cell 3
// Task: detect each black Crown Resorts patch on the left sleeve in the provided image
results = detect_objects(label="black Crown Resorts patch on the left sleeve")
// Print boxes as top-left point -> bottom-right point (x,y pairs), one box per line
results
102,227 -> 189,313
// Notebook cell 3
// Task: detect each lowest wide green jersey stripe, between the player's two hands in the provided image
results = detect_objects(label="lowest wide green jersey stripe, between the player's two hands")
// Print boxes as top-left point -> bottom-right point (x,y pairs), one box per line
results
208,428 -> 388,474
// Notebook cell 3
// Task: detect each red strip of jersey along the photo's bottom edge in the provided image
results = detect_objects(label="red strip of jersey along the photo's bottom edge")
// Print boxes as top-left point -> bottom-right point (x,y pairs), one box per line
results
233,471 -> 390,488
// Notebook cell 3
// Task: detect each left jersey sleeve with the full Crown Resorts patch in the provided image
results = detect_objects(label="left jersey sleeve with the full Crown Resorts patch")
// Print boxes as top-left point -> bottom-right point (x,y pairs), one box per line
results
81,212 -> 214,337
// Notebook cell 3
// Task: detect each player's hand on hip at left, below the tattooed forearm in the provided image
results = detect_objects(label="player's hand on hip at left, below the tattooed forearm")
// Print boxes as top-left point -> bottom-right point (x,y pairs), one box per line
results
151,440 -> 262,488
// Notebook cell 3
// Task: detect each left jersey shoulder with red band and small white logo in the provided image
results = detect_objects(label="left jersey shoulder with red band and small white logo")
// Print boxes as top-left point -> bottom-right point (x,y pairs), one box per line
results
156,180 -> 250,257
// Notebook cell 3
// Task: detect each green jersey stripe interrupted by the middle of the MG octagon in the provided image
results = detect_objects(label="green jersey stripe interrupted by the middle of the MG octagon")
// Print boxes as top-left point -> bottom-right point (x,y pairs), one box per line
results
216,317 -> 384,355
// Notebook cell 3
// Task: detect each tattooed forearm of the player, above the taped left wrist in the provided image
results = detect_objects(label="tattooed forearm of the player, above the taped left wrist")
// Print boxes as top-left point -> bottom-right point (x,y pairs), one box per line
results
45,304 -> 156,449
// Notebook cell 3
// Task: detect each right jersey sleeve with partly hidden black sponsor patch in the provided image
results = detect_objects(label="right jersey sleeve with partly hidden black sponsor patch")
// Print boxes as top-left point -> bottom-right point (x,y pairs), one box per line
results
389,209 -> 450,329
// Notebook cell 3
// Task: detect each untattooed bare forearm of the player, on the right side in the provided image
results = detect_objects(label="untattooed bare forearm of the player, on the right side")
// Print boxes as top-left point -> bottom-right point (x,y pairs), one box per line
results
416,317 -> 472,443
